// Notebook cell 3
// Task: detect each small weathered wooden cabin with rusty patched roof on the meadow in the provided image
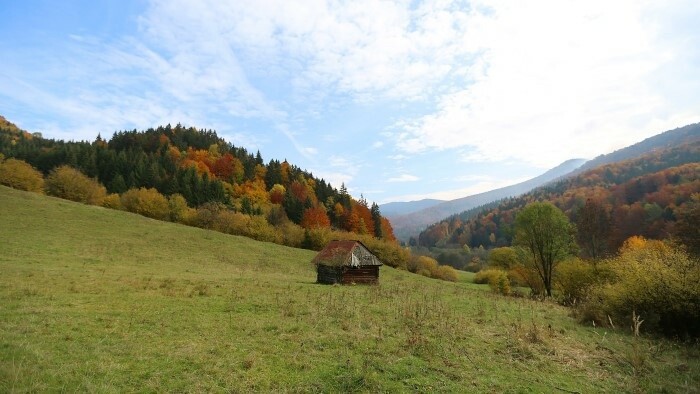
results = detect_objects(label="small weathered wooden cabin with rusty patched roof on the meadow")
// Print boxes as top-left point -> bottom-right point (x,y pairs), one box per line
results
312,240 -> 382,284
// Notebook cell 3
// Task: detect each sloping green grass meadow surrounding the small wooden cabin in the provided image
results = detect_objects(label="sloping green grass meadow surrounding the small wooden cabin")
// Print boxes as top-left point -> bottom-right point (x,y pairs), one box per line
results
0,187 -> 700,393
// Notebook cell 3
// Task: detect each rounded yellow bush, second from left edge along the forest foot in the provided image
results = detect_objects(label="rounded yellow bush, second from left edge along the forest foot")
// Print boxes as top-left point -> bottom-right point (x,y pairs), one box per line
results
45,166 -> 107,205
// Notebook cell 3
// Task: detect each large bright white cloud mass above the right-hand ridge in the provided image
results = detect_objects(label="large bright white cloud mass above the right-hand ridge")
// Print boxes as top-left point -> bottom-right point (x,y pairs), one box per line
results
394,1 -> 697,167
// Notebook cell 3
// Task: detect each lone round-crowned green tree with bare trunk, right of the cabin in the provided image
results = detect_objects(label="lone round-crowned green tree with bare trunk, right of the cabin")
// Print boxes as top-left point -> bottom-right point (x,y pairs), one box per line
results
514,202 -> 576,297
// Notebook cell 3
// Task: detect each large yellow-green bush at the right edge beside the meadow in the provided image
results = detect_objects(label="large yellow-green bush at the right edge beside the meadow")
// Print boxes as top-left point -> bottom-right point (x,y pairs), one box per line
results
578,237 -> 700,338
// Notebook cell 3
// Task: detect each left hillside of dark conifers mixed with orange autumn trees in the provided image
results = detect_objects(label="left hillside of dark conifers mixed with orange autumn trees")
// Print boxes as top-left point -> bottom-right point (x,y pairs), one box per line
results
0,114 -> 395,241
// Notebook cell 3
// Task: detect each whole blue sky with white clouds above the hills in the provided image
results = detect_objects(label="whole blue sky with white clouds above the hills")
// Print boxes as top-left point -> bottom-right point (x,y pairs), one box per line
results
0,0 -> 700,204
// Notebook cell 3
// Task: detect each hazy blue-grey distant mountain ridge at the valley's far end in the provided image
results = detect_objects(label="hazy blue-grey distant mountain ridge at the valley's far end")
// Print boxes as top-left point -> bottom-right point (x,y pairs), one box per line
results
382,159 -> 586,242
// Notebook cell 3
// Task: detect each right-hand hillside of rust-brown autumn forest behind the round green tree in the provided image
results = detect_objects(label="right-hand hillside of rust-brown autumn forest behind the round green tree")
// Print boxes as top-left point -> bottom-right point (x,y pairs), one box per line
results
418,137 -> 700,257
